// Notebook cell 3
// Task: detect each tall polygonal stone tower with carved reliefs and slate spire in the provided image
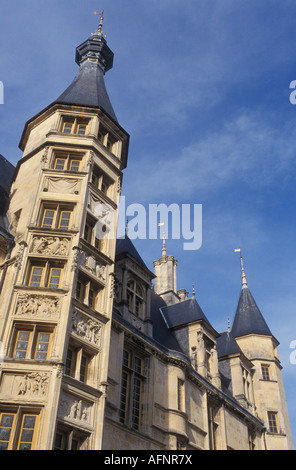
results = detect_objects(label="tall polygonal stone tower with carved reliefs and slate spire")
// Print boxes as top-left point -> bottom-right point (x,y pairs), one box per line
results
0,18 -> 129,450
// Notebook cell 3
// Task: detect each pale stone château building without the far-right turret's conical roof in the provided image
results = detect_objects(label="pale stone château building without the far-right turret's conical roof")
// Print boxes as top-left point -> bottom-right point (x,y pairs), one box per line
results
0,23 -> 293,451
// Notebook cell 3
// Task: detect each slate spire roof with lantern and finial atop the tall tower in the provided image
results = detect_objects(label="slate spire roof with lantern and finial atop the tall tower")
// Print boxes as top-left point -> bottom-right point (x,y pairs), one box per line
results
56,17 -> 117,121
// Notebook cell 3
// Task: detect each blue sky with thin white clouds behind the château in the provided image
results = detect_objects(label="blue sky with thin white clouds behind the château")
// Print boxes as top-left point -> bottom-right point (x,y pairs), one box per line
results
0,0 -> 296,448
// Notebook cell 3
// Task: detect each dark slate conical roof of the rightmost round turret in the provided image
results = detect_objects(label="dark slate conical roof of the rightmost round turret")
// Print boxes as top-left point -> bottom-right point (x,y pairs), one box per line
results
231,286 -> 272,338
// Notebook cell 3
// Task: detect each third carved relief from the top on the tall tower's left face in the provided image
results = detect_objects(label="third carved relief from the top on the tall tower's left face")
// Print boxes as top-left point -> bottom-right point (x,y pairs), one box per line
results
15,294 -> 61,318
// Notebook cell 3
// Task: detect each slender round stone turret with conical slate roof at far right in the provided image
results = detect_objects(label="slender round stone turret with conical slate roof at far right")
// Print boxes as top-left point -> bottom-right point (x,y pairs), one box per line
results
231,252 -> 293,450
